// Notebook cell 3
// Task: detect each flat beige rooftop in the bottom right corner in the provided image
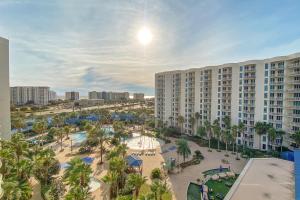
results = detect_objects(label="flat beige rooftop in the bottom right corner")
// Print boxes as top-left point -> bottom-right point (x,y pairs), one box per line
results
225,158 -> 295,200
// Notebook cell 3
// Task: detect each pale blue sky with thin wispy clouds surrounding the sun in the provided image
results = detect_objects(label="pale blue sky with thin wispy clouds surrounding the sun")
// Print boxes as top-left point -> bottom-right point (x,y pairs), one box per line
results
0,0 -> 300,96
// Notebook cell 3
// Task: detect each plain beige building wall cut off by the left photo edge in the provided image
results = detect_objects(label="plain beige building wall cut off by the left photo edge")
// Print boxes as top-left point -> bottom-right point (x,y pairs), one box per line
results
0,37 -> 11,139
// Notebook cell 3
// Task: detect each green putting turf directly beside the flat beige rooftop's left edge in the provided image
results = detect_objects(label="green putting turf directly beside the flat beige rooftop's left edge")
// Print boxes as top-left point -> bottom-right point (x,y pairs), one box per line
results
205,178 -> 236,197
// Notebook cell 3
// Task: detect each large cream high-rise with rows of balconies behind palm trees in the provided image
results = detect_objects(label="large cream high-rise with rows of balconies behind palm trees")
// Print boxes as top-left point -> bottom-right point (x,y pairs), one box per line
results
155,53 -> 300,150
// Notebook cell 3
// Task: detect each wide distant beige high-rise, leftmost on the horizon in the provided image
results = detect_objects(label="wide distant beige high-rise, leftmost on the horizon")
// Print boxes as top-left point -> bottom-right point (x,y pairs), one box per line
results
10,86 -> 50,105
